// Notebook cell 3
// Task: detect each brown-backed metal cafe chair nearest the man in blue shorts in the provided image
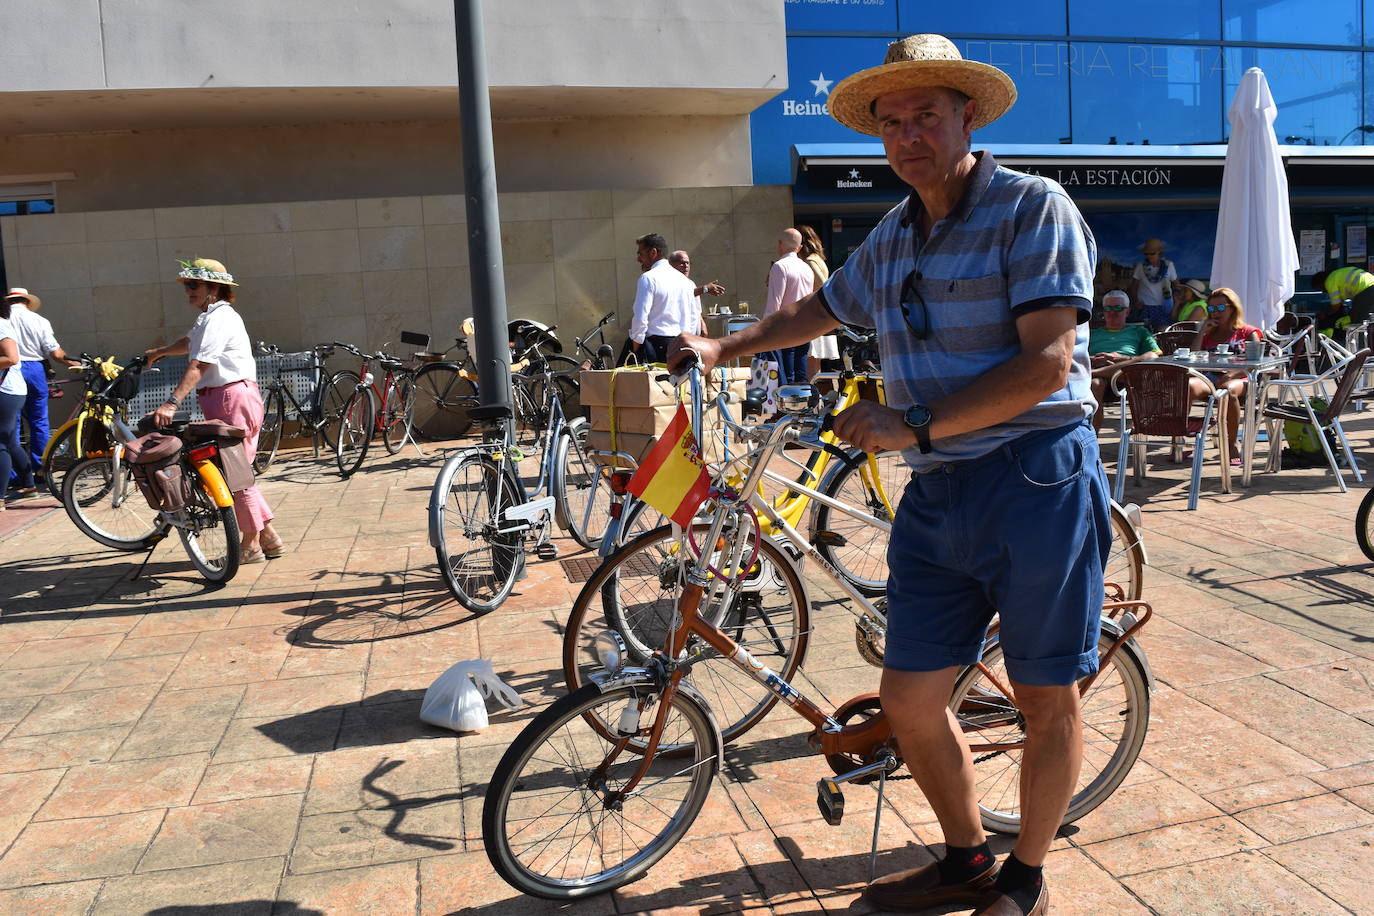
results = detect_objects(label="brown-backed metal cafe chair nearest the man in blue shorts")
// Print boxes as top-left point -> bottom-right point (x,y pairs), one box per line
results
1112,363 -> 1231,509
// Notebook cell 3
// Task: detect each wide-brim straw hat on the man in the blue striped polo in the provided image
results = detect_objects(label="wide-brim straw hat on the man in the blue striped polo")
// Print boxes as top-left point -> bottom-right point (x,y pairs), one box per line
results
829,34 -> 1017,136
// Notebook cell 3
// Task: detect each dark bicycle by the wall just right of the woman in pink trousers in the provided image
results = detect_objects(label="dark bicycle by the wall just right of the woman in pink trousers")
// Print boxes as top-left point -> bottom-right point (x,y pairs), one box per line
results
253,341 -> 359,474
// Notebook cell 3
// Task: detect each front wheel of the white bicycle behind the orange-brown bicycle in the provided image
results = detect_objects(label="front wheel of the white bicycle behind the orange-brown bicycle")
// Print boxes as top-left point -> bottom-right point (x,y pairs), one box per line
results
563,525 -> 811,743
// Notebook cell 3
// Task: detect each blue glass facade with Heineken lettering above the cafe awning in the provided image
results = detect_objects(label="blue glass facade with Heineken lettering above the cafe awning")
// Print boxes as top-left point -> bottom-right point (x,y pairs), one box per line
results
750,0 -> 1374,184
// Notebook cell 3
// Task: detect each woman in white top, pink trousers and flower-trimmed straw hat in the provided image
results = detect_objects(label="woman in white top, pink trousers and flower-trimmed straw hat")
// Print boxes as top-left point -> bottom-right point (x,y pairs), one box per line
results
144,258 -> 283,563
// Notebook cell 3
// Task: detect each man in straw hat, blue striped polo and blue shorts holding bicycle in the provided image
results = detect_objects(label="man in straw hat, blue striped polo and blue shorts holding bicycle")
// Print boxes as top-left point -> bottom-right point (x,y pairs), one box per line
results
672,34 -> 1112,916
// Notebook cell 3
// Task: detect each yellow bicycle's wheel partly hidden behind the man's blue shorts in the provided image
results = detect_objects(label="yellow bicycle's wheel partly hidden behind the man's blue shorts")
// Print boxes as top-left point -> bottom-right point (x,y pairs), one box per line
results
809,452 -> 911,597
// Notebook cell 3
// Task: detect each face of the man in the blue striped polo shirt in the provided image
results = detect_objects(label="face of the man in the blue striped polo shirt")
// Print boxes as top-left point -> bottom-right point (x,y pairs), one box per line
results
874,88 -> 977,188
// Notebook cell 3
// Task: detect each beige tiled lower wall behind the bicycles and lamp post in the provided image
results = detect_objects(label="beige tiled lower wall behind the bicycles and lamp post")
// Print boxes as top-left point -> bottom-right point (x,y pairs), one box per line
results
0,185 -> 791,358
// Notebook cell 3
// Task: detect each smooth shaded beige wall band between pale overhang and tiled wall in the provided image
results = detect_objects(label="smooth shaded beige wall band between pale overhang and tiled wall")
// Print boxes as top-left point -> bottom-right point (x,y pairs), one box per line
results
0,115 -> 752,213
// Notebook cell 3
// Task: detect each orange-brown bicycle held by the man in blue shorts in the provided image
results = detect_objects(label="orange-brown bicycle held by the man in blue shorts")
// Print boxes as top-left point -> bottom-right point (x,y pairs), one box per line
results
482,359 -> 1151,900
